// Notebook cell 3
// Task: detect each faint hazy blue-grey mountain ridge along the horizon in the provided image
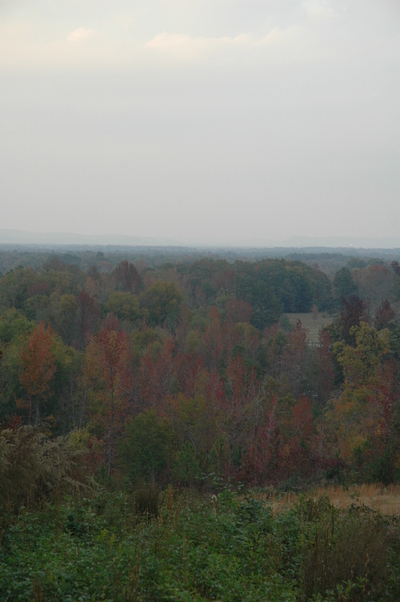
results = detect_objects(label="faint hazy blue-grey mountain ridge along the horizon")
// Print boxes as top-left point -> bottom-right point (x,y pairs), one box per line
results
0,229 -> 400,249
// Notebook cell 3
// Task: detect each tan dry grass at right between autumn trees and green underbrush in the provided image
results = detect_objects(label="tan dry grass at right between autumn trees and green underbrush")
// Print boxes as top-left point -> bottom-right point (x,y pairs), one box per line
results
254,485 -> 400,516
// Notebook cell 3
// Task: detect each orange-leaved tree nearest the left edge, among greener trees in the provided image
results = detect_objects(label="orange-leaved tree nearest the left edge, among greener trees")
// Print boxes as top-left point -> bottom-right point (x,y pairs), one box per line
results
19,322 -> 56,424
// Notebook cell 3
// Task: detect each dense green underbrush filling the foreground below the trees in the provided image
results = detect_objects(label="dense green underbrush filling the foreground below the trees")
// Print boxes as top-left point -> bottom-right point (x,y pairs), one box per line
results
0,488 -> 400,602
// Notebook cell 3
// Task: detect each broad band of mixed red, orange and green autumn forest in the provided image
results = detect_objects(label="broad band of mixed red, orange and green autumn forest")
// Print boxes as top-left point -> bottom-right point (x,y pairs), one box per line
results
0,251 -> 400,487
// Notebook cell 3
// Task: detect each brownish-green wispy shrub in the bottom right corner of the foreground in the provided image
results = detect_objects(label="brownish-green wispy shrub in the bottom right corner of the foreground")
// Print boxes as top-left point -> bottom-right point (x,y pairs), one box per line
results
299,498 -> 393,601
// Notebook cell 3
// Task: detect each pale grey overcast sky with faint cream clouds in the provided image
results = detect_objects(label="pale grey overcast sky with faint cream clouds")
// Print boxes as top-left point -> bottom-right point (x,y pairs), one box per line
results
0,0 -> 400,244
